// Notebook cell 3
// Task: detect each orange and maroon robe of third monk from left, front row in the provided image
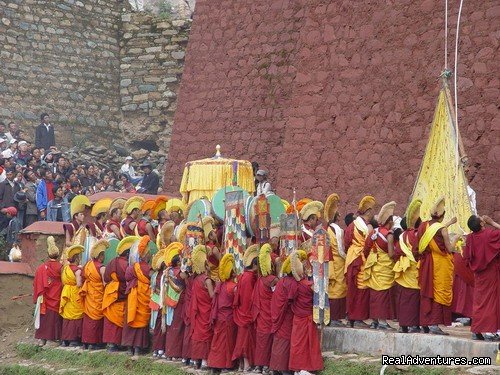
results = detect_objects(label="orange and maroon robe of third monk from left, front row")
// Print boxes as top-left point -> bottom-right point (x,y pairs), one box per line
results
80,260 -> 104,344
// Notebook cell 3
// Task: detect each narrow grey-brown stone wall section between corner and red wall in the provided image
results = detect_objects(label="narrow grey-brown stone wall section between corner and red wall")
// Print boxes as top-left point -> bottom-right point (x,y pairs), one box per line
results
120,13 -> 191,161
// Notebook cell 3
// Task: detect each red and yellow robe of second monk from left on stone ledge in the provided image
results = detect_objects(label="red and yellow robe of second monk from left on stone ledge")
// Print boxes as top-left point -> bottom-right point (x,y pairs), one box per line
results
344,222 -> 370,320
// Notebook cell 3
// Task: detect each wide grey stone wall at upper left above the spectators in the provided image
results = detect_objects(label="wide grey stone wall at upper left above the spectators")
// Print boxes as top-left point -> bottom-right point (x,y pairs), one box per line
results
0,0 -> 122,146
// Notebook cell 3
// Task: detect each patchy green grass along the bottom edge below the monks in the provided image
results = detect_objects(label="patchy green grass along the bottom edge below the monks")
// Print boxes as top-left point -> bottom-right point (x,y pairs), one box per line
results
0,344 -> 458,375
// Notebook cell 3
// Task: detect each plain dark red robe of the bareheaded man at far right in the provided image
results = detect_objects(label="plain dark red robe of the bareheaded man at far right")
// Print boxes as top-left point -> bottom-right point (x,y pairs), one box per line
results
463,228 -> 500,333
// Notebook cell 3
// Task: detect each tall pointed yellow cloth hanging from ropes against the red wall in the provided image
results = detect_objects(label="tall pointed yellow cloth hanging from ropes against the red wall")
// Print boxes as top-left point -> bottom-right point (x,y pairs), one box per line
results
411,83 -> 472,234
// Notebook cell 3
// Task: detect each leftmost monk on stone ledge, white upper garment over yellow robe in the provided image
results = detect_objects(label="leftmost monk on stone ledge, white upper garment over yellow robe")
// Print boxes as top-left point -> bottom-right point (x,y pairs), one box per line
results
324,193 -> 347,327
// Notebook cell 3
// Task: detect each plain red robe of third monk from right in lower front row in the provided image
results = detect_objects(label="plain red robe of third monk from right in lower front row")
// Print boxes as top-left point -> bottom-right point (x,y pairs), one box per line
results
252,275 -> 276,366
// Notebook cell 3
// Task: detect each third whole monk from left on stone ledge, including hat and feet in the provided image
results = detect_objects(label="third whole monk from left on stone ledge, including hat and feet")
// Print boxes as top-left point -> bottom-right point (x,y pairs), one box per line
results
364,202 -> 396,329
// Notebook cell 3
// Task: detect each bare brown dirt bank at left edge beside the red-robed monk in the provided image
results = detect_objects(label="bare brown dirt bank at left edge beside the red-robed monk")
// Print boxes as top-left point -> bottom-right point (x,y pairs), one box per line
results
0,275 -> 34,359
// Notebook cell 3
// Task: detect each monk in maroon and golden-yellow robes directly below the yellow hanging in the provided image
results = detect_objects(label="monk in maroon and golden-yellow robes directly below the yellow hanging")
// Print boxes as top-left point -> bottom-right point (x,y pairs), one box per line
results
417,198 -> 457,335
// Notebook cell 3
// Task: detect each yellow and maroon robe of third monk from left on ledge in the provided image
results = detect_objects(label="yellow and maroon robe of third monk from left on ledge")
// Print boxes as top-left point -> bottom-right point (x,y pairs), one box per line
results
364,227 -> 396,319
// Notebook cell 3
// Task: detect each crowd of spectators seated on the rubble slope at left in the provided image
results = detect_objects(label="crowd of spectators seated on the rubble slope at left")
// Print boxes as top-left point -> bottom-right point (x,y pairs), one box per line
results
0,113 -> 160,260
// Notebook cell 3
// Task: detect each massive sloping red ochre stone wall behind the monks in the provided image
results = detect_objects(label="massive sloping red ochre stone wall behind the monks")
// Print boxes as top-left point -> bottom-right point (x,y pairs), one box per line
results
165,0 -> 500,220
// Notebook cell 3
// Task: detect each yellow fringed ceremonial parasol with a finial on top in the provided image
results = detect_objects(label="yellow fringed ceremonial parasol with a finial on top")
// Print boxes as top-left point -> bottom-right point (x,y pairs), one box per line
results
179,145 -> 255,204
